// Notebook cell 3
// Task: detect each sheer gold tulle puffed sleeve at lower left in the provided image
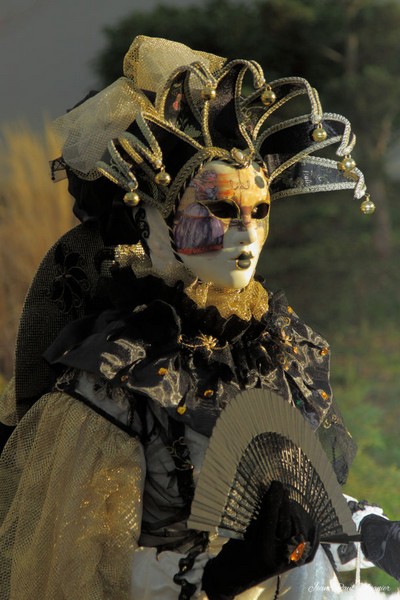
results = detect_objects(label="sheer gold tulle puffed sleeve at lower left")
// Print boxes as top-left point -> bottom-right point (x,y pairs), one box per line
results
0,393 -> 145,600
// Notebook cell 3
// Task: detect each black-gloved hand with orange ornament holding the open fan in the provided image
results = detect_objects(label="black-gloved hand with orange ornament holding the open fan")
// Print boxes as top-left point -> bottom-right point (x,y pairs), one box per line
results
202,481 -> 319,600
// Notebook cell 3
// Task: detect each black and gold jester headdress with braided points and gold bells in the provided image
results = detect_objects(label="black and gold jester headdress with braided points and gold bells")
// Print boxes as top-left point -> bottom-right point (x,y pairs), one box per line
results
53,36 -> 374,220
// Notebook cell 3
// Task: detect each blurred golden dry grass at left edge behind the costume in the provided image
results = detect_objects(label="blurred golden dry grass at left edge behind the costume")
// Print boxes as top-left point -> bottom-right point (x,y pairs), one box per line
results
0,123 -> 75,378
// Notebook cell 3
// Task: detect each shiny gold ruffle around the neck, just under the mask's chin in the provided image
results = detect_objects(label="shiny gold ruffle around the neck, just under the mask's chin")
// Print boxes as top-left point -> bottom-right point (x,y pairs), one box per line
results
184,279 -> 268,321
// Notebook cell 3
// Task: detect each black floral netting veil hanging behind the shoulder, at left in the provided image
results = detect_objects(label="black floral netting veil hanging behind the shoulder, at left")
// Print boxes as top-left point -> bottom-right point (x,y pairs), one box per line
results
15,225 -> 103,416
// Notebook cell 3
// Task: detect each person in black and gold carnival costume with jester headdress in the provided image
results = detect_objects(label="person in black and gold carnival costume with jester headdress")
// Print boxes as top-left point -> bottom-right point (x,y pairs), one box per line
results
0,36 -> 394,600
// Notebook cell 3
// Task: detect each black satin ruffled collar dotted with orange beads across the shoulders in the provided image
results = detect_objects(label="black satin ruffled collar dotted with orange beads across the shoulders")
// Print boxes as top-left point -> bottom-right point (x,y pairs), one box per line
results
45,278 -> 331,435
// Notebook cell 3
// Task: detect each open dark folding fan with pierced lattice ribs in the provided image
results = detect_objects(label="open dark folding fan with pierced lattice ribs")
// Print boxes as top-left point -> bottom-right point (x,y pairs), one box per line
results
188,389 -> 360,543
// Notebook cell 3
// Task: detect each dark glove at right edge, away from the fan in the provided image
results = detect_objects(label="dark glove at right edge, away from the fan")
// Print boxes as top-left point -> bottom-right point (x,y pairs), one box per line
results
360,515 -> 400,581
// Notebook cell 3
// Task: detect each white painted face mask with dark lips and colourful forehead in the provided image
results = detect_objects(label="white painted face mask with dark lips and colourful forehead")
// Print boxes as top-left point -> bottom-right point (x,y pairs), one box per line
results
173,161 -> 270,289
